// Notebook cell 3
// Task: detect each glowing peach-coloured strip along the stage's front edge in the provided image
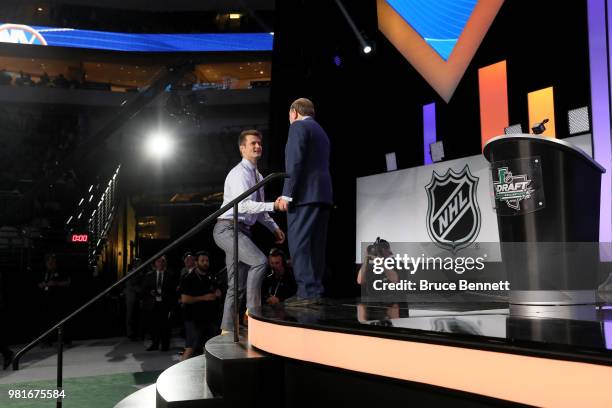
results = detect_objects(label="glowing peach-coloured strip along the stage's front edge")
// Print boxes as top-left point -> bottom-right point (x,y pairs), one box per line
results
248,315 -> 612,407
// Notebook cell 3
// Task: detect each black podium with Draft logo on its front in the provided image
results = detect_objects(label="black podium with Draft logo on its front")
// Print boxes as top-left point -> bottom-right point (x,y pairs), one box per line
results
483,135 -> 605,306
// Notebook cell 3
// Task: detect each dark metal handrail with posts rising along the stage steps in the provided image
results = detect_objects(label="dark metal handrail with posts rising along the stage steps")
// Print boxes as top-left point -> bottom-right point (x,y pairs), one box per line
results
13,173 -> 288,382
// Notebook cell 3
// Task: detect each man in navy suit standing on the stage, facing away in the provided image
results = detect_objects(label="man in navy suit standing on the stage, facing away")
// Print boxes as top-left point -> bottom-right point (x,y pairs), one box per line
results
277,98 -> 332,300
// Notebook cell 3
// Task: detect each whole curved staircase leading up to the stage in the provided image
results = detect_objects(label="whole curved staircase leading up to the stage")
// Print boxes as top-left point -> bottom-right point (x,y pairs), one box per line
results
115,335 -> 285,408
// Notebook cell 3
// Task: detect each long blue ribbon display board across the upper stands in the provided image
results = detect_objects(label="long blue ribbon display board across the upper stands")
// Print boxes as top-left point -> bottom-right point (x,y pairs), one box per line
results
0,24 -> 274,52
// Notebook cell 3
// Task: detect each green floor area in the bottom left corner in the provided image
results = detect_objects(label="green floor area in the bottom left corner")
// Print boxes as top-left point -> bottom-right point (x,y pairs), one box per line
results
0,371 -> 160,408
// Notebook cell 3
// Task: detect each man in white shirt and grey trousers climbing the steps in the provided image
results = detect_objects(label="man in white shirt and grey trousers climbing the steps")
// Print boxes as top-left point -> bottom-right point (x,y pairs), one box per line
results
213,130 -> 285,332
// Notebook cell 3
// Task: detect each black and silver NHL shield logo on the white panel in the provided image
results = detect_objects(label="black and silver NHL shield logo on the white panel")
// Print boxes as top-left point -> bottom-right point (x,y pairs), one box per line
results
425,165 -> 480,252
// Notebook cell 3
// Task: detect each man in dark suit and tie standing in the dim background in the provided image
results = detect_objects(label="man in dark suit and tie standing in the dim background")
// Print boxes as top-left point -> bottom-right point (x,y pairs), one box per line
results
142,256 -> 178,351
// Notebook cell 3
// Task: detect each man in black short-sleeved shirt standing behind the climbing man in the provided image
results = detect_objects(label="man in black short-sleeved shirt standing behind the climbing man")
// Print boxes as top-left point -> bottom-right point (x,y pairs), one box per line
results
180,251 -> 221,360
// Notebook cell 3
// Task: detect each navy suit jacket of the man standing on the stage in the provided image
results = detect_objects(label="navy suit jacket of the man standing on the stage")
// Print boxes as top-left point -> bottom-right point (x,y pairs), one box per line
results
283,118 -> 332,205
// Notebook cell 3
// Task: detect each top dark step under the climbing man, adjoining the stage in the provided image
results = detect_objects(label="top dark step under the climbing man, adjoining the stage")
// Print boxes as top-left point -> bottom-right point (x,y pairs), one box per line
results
205,335 -> 284,407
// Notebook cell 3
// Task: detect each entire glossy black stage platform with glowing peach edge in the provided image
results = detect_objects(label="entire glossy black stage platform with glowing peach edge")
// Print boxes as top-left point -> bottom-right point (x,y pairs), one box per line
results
248,294 -> 612,407
